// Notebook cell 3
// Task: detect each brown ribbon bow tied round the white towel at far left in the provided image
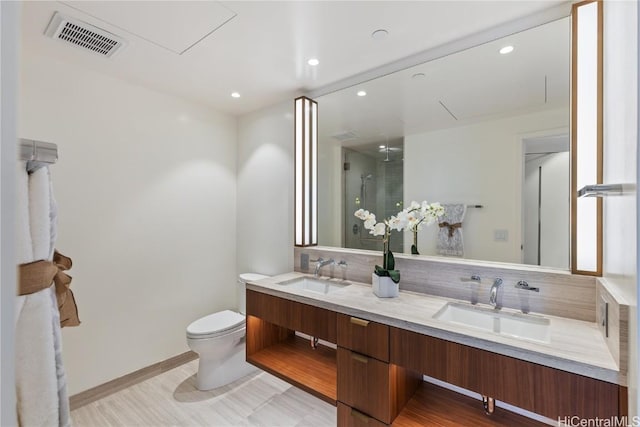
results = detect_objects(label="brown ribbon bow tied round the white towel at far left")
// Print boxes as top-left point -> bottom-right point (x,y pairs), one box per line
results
18,251 -> 80,328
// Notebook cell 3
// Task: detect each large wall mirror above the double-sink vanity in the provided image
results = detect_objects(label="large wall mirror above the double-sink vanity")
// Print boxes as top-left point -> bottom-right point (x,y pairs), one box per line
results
315,17 -> 571,269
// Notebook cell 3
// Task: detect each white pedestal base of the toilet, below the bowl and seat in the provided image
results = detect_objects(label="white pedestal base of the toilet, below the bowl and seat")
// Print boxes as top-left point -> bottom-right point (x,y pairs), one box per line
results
196,340 -> 258,391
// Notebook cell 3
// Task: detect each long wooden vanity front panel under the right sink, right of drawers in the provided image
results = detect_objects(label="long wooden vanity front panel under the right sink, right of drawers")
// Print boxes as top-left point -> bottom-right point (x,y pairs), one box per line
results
390,328 -> 624,419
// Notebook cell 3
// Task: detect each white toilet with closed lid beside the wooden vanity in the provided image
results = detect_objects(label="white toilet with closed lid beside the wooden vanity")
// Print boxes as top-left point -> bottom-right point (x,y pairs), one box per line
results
187,273 -> 268,390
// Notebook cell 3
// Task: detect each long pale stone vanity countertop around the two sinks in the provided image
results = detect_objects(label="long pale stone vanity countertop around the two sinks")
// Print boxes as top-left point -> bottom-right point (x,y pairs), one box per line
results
247,272 -> 626,385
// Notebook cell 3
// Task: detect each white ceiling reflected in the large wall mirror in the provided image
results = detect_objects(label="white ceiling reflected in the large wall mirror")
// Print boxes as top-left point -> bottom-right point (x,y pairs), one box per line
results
316,17 -> 571,147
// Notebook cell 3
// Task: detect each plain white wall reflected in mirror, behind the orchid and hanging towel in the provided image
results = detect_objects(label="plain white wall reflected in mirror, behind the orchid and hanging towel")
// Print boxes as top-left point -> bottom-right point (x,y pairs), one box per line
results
404,109 -> 569,263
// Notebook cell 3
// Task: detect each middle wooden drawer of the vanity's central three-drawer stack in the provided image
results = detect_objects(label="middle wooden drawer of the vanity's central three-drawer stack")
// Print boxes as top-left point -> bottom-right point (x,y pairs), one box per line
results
337,347 -> 391,423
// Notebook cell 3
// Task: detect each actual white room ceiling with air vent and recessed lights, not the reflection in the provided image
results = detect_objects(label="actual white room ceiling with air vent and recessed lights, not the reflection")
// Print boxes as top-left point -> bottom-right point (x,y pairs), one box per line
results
22,0 -> 564,115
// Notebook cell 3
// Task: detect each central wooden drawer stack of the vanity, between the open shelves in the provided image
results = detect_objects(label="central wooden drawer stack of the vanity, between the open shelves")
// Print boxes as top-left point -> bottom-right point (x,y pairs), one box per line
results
337,314 -> 422,427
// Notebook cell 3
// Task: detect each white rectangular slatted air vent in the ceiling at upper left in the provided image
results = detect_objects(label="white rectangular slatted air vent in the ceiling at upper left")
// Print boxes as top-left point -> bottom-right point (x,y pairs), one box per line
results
44,12 -> 125,58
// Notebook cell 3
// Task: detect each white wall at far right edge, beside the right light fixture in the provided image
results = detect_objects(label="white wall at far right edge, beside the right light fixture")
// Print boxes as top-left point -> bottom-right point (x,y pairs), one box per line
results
603,1 -> 638,416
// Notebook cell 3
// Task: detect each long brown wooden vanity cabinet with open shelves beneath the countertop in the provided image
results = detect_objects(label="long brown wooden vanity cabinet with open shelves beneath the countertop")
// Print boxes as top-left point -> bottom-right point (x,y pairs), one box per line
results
246,290 -> 627,427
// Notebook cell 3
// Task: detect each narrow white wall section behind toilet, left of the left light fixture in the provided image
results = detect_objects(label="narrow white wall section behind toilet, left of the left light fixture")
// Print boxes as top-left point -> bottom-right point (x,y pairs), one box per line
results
237,100 -> 294,275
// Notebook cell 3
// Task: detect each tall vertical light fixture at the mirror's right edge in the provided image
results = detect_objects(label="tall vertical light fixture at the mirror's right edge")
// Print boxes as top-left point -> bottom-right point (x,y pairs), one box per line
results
571,0 -> 603,276
